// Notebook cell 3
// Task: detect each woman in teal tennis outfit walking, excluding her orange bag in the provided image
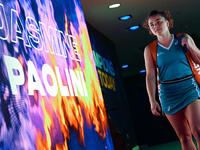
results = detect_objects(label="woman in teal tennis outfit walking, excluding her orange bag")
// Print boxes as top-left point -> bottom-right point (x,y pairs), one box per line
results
144,10 -> 200,150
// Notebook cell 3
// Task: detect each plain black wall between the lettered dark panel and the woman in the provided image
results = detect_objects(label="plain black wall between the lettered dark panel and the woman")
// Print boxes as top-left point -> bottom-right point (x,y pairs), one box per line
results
124,70 -> 178,146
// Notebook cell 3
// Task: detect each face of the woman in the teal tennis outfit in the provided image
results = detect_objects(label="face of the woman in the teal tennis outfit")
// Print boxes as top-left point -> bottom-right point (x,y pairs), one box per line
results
148,15 -> 169,36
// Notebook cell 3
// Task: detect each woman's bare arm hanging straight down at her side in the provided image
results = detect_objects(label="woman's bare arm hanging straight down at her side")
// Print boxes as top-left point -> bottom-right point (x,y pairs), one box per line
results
144,46 -> 161,116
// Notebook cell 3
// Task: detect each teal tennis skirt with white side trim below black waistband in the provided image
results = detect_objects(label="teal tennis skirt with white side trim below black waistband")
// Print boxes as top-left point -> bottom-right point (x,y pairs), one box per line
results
159,77 -> 200,115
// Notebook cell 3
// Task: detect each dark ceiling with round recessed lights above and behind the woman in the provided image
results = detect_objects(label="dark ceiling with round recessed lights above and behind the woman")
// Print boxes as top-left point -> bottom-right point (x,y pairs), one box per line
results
81,0 -> 200,77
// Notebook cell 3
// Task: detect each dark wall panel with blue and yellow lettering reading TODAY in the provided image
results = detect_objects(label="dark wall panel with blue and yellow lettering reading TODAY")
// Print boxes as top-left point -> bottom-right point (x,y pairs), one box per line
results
87,23 -> 137,147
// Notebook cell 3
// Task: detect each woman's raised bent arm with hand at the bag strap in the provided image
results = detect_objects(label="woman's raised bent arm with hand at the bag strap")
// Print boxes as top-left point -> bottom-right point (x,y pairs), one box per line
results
182,34 -> 200,64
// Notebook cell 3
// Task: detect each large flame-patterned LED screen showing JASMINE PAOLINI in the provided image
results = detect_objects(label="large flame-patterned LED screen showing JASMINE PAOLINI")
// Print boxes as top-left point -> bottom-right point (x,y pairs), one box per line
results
0,0 -> 113,150
